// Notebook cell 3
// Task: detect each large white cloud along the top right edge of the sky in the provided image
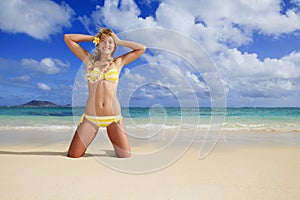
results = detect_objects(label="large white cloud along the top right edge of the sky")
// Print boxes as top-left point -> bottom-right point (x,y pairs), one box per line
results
156,0 -> 300,52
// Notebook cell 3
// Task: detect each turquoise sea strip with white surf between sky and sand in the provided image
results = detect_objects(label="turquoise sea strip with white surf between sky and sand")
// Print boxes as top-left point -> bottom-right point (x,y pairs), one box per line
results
0,107 -> 300,132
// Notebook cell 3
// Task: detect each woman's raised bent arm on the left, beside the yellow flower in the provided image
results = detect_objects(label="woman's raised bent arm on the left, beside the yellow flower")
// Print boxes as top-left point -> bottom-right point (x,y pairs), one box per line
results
64,34 -> 94,61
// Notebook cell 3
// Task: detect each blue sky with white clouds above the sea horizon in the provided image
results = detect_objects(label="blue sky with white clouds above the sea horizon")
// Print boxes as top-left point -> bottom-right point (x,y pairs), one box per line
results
0,0 -> 300,107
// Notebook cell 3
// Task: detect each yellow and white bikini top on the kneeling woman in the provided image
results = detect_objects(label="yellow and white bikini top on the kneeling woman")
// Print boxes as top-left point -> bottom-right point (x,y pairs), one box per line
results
87,67 -> 119,83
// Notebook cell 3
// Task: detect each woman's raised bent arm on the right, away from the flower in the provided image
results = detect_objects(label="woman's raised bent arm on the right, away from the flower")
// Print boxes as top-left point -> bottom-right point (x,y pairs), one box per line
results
116,37 -> 146,69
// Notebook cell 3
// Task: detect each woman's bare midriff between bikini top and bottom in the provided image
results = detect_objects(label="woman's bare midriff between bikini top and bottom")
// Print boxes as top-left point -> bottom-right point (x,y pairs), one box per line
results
85,80 -> 121,116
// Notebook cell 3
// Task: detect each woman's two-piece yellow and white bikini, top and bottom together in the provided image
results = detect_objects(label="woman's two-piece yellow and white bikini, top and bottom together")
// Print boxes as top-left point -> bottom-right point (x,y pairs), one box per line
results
79,67 -> 123,127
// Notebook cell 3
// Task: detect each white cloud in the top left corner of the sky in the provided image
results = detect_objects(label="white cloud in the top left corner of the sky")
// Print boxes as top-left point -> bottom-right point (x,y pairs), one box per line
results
0,0 -> 74,40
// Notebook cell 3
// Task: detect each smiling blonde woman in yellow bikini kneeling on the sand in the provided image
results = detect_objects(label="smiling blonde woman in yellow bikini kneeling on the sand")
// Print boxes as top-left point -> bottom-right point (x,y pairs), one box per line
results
64,28 -> 146,158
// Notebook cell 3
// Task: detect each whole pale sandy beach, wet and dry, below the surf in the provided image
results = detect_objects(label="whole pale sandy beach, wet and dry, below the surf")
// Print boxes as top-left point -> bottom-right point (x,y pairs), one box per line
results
0,108 -> 300,200
